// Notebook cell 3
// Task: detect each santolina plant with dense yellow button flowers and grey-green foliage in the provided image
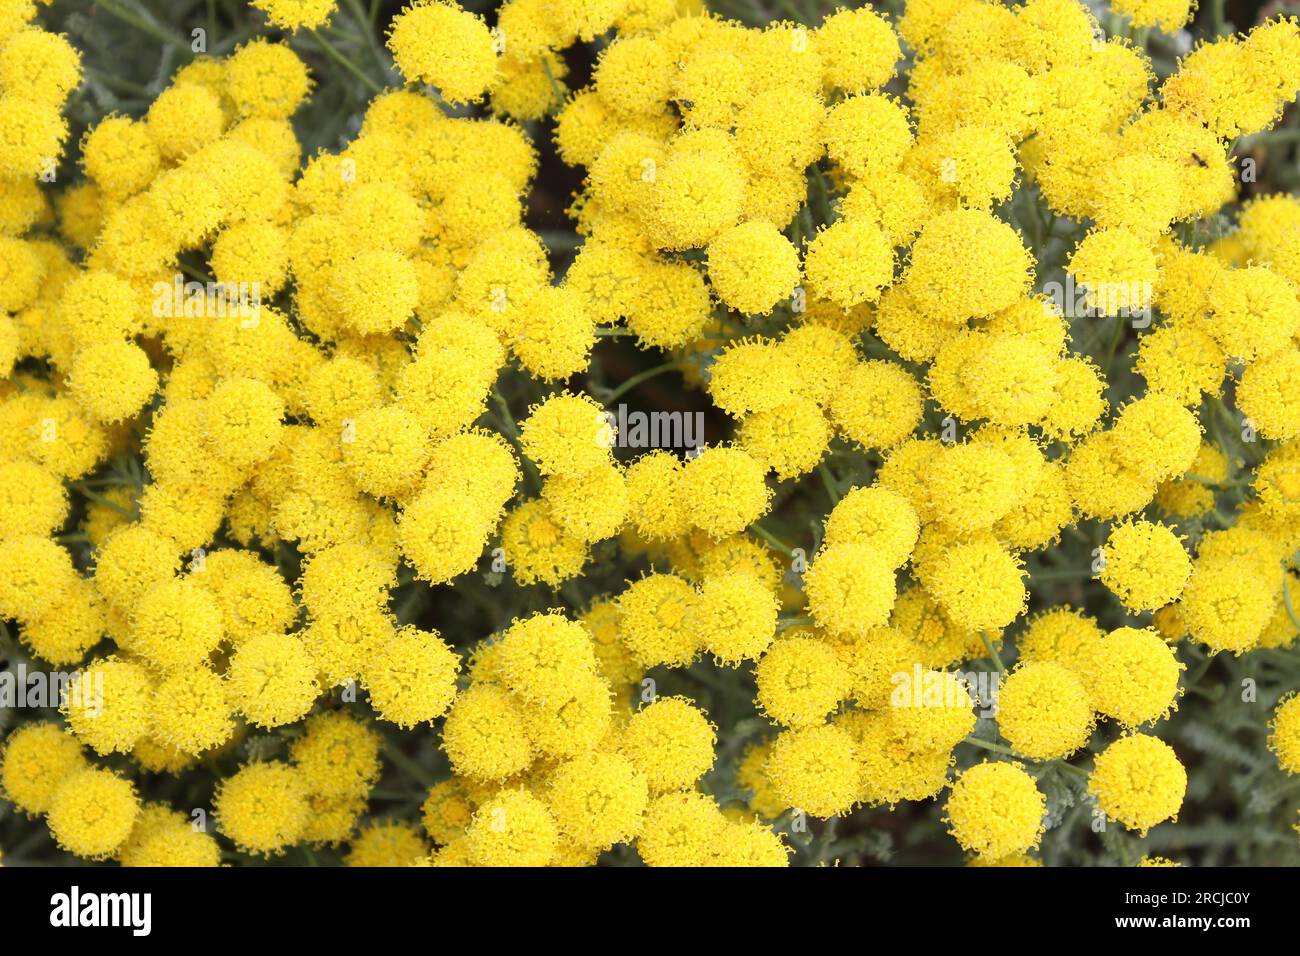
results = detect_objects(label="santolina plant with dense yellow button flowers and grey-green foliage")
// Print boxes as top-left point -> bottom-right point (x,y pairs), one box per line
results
0,0 -> 1300,866
